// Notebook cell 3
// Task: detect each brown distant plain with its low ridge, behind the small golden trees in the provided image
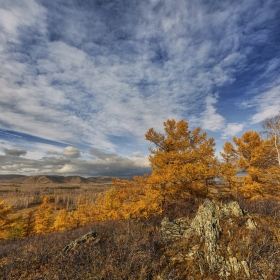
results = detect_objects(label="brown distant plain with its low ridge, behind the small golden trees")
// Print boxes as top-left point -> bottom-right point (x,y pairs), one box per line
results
0,175 -> 112,209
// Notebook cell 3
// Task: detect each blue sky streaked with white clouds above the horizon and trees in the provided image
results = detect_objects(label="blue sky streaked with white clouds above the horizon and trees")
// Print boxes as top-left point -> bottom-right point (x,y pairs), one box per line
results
0,0 -> 280,177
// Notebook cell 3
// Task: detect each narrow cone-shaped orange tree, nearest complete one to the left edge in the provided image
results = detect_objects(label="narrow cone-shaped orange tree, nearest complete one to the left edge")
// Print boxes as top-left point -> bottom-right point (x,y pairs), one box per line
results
35,197 -> 54,233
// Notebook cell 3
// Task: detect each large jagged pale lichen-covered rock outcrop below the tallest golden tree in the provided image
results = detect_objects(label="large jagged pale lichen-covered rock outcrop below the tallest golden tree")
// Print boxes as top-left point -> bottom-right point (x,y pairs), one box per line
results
161,199 -> 257,279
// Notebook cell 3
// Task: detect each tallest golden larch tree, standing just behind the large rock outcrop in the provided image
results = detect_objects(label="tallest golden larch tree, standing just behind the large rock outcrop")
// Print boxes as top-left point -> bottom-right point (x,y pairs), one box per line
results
146,120 -> 218,201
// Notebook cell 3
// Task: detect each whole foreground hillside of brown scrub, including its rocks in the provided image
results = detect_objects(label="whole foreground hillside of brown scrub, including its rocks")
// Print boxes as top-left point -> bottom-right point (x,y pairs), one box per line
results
0,199 -> 280,280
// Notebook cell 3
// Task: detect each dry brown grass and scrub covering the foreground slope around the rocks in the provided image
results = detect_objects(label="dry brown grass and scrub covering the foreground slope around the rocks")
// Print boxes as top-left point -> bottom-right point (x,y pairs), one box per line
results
0,199 -> 280,280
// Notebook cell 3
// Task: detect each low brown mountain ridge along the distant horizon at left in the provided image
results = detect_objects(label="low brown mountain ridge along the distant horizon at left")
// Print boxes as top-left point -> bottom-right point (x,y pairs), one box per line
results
0,175 -> 112,184
